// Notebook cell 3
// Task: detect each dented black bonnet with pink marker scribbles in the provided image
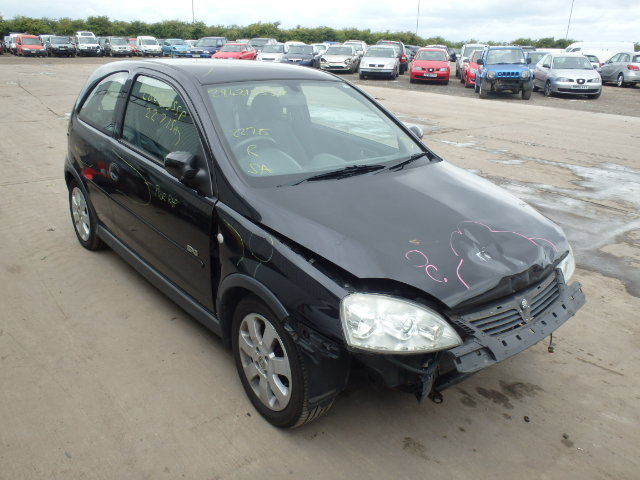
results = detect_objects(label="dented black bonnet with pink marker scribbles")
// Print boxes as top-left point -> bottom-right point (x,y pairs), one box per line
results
239,162 -> 569,307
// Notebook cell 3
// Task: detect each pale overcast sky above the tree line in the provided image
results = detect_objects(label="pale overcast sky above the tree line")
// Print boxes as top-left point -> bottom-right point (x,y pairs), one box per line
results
0,0 -> 640,42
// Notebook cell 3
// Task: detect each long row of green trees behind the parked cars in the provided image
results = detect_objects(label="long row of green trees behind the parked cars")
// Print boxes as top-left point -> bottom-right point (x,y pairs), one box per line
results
0,16 -> 640,48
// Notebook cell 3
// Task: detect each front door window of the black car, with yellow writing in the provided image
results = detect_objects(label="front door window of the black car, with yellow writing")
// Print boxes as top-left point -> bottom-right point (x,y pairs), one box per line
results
122,76 -> 202,163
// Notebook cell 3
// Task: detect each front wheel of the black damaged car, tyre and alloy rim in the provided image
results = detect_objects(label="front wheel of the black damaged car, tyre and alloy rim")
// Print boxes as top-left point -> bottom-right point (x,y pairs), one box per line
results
231,295 -> 333,428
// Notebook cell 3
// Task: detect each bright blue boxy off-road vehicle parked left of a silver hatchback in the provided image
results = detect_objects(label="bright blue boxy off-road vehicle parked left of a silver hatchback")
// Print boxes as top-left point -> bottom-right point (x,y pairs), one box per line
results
475,46 -> 533,100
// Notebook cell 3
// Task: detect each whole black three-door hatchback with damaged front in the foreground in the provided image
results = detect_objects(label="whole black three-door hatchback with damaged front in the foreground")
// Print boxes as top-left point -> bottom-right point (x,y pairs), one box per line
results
65,60 -> 585,427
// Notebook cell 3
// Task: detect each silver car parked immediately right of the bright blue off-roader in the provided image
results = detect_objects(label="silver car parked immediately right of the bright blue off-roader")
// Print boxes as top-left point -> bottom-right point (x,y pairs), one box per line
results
533,53 -> 602,98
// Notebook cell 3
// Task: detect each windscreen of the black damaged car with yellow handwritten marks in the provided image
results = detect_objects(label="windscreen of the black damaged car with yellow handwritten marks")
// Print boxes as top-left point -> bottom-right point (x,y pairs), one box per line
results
205,80 -> 423,185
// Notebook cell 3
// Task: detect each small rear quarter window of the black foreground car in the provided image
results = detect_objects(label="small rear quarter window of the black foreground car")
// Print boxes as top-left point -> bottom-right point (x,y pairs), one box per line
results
78,72 -> 128,133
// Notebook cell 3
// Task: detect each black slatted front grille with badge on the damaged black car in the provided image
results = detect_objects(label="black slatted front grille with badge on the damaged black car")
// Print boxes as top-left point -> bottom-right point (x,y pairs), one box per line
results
452,272 -> 560,337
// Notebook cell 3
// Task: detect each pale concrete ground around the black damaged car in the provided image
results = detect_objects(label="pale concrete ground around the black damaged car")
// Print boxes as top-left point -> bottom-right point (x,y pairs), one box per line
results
0,59 -> 640,480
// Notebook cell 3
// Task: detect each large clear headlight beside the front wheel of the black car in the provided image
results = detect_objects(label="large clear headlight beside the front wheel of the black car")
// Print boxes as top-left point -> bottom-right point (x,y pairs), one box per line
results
340,293 -> 462,353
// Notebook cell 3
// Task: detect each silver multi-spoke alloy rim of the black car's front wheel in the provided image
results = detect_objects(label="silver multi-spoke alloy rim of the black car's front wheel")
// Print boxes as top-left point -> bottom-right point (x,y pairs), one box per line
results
238,313 -> 292,412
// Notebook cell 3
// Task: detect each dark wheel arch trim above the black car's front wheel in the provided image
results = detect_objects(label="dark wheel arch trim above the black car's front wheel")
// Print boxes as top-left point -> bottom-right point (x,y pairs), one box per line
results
216,273 -> 289,345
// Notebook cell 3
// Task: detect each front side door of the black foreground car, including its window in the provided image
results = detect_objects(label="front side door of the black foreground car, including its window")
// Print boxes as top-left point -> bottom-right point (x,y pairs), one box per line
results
110,73 -> 218,311
